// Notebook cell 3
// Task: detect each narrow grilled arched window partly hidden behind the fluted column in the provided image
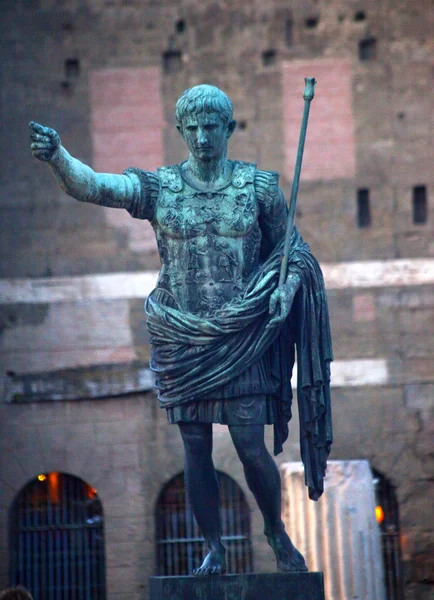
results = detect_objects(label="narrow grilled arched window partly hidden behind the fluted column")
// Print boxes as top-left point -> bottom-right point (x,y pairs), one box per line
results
374,471 -> 404,600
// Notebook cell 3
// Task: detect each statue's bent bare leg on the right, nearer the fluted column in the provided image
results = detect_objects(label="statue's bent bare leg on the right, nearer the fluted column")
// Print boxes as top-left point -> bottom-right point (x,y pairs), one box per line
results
229,425 -> 307,571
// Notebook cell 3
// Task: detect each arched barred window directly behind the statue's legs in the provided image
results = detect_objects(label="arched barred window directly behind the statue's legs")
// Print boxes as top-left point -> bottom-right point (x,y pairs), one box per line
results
156,471 -> 253,575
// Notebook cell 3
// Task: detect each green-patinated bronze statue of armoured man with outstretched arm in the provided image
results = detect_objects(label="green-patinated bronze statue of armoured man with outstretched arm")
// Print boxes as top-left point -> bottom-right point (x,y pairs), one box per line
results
30,85 -> 332,575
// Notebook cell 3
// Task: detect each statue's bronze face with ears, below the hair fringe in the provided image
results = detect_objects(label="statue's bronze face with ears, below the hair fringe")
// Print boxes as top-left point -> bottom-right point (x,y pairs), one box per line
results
179,112 -> 235,162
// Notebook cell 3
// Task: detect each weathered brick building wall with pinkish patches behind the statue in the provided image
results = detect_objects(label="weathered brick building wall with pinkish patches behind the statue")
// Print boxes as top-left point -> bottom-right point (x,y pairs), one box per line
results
0,0 -> 434,600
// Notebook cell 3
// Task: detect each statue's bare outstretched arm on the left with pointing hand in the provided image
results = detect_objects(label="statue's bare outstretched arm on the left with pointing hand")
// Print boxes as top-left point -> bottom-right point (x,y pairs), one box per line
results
30,121 -> 140,210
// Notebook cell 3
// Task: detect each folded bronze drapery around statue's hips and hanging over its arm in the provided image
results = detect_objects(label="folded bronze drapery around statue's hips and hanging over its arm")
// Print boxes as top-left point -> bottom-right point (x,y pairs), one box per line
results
146,230 -> 333,500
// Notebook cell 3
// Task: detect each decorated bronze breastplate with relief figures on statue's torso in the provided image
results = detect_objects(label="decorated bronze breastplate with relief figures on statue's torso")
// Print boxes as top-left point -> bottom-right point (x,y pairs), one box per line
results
153,162 -> 261,314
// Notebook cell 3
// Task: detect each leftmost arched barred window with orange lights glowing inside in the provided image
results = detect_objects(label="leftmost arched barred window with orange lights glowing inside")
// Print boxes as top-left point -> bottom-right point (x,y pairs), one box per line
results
10,473 -> 106,600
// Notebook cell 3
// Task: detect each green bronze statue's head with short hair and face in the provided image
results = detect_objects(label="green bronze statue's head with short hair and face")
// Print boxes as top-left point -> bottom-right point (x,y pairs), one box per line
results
175,84 -> 236,161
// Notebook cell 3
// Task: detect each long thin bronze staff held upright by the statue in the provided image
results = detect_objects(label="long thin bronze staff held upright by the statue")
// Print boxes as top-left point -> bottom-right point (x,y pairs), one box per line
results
279,77 -> 316,287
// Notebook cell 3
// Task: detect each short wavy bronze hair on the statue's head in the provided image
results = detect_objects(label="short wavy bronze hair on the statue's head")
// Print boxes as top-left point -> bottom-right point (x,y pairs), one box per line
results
175,83 -> 234,125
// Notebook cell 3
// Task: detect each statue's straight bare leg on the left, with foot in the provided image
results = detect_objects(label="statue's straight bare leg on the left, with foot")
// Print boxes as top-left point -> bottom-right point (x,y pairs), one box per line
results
178,422 -> 226,576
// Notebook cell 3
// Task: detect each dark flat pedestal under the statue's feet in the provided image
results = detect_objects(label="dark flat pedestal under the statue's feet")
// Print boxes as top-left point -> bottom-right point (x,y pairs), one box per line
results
149,573 -> 324,600
